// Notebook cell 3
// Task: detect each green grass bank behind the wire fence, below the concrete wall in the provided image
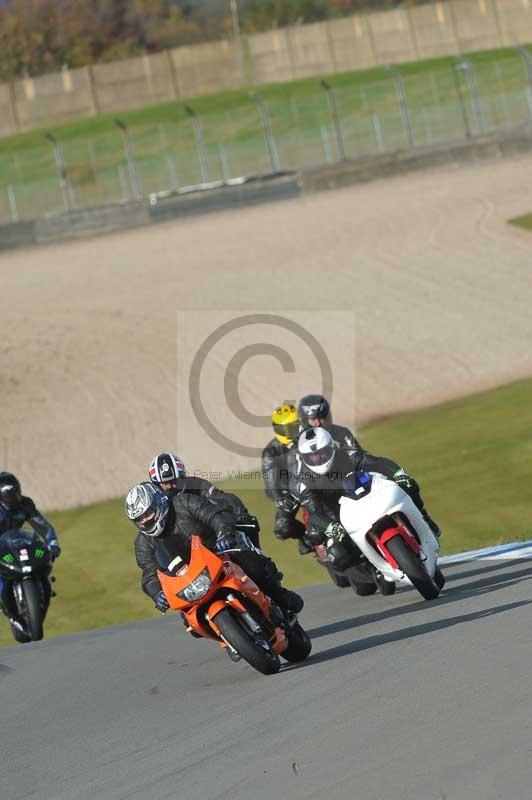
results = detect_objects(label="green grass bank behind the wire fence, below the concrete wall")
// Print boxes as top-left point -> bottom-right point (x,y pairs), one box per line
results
0,42 -> 529,221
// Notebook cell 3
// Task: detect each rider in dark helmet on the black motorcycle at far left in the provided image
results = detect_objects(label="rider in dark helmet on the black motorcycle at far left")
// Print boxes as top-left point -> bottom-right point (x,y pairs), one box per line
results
0,472 -> 61,638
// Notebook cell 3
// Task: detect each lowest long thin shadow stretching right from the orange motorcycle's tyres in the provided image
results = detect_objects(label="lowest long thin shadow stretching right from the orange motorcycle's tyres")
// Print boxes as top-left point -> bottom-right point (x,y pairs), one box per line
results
290,600 -> 532,672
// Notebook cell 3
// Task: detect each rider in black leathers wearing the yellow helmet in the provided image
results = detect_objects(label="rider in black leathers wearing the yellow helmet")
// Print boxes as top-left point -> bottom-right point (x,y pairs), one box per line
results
261,403 -> 312,555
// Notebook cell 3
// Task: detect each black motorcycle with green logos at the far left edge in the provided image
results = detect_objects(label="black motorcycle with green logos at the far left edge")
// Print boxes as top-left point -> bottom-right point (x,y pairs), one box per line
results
0,530 -> 53,644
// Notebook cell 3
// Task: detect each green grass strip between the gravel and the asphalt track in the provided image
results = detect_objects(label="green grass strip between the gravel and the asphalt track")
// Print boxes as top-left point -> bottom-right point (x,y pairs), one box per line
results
0,380 -> 532,646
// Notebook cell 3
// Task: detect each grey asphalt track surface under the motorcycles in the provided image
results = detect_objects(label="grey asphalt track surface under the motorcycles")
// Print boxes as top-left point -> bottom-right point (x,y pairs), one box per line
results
0,557 -> 532,800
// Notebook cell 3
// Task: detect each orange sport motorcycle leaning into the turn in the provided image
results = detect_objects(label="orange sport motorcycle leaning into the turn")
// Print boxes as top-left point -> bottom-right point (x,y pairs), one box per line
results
156,536 -> 312,675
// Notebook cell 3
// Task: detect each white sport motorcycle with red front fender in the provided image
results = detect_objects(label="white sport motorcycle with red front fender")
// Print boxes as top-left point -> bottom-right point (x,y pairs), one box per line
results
340,471 -> 445,600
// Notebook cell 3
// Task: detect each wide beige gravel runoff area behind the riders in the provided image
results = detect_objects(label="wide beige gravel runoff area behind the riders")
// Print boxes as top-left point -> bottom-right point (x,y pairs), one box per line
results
0,156 -> 532,508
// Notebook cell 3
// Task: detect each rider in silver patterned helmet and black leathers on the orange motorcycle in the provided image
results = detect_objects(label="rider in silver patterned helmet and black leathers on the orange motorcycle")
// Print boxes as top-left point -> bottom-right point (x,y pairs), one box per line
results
125,481 -> 303,614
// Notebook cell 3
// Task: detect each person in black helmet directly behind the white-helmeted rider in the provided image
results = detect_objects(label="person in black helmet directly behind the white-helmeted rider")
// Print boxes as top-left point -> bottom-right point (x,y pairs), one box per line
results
298,394 -> 441,537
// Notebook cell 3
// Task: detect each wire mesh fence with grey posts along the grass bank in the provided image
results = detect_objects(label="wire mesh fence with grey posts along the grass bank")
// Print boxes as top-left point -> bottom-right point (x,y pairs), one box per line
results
0,48 -> 532,222
